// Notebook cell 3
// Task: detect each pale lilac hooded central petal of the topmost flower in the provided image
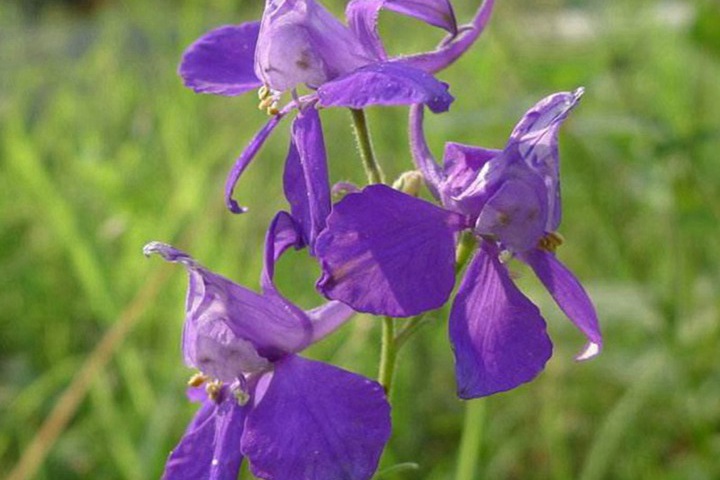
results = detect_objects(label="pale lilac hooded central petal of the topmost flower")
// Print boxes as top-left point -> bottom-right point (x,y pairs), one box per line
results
255,0 -> 377,91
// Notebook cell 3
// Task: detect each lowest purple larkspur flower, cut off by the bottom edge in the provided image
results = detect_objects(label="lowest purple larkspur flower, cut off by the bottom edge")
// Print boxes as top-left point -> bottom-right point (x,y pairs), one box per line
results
144,212 -> 390,480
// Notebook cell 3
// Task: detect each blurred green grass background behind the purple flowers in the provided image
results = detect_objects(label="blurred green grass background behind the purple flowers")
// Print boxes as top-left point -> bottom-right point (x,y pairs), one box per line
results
0,0 -> 720,480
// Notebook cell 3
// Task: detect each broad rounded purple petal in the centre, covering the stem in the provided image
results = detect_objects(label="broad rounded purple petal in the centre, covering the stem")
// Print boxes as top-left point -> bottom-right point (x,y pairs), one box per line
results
316,185 -> 466,317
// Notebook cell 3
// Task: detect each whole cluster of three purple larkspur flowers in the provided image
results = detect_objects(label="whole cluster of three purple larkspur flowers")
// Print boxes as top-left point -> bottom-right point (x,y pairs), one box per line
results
145,0 -> 602,480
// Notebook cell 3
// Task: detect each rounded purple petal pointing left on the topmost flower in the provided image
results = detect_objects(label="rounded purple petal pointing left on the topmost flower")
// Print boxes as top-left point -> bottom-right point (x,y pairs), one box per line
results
178,22 -> 262,96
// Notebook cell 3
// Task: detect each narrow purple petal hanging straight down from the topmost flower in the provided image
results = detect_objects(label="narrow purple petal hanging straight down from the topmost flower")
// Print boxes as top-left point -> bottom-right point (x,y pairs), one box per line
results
283,107 -> 330,253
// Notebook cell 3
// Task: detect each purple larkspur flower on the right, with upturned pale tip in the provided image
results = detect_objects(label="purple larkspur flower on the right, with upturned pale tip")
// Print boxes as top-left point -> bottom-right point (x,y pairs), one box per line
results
316,89 -> 602,398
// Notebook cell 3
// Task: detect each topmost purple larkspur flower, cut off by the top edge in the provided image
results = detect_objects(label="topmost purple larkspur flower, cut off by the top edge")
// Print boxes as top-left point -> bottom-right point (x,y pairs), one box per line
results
179,0 -> 494,213
